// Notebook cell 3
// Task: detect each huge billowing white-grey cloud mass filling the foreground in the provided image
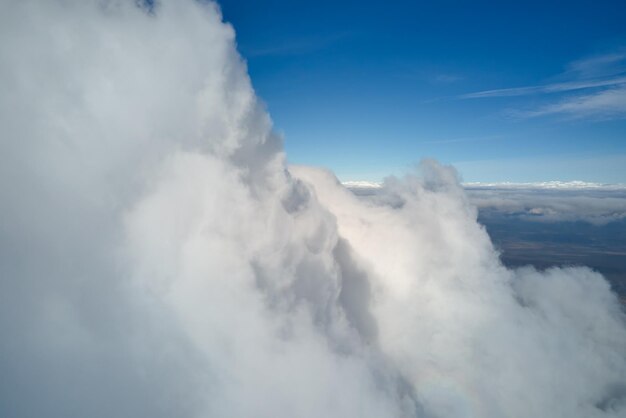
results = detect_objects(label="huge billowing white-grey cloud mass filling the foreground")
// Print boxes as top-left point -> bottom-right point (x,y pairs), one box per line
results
0,0 -> 626,418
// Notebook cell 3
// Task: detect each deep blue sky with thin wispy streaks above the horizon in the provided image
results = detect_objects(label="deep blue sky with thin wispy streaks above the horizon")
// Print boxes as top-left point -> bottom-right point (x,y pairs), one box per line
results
220,0 -> 626,183
